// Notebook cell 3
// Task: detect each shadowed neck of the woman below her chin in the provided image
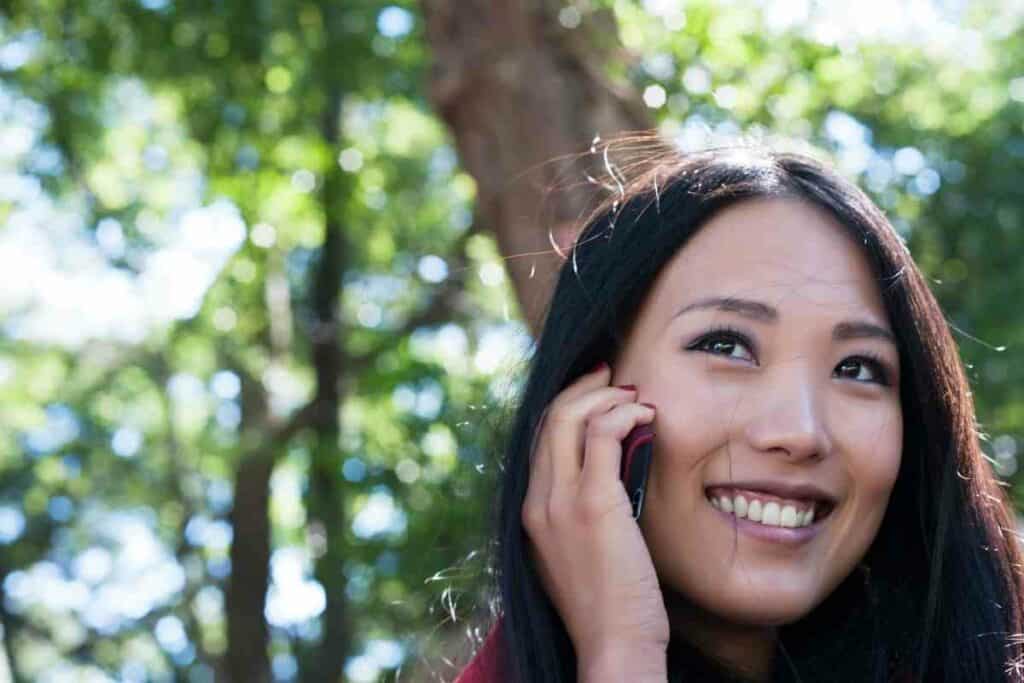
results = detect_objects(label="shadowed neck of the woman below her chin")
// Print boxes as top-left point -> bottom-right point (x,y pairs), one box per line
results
665,589 -> 778,681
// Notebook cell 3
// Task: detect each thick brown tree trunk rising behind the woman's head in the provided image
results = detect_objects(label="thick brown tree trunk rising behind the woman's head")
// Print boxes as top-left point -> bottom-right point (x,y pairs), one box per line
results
422,0 -> 650,334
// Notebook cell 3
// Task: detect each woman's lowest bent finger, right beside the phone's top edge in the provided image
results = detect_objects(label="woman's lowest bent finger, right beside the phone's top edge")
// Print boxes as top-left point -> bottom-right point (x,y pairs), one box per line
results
580,403 -> 654,509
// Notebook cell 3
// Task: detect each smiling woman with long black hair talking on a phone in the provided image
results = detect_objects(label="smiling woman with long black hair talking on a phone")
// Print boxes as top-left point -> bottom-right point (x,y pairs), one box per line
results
459,142 -> 1024,683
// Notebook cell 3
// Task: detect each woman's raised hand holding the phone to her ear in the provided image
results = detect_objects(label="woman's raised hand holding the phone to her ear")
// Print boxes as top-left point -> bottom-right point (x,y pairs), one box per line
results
522,364 -> 669,680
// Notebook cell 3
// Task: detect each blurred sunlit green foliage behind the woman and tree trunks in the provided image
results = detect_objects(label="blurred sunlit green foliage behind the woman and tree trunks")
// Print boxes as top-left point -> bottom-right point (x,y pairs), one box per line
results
0,0 -> 1024,681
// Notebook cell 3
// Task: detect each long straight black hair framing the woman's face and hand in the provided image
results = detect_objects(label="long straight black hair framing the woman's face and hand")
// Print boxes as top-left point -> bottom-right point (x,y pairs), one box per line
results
481,135 -> 1024,683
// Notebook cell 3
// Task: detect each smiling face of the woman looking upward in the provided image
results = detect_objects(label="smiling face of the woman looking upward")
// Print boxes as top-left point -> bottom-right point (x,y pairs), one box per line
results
613,194 -> 903,626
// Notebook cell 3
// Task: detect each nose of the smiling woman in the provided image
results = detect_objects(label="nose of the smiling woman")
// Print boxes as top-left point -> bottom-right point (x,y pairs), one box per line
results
745,362 -> 830,461
